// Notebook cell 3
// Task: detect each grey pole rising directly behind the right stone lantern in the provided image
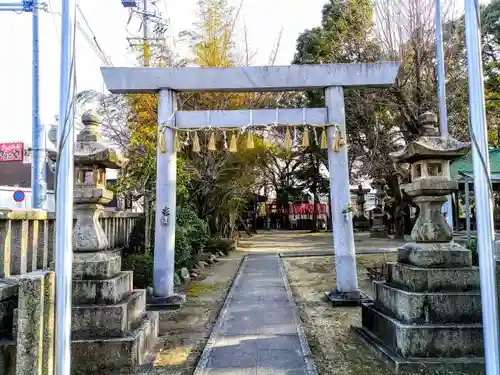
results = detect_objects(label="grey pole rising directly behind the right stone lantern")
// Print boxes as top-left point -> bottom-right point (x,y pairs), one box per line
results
435,0 -> 453,230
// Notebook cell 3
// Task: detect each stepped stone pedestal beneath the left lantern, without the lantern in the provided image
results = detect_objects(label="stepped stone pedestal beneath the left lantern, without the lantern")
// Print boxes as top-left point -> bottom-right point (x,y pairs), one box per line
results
71,252 -> 158,375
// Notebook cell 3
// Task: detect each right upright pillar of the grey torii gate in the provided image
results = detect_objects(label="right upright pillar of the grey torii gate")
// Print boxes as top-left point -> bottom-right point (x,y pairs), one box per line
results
325,87 -> 359,295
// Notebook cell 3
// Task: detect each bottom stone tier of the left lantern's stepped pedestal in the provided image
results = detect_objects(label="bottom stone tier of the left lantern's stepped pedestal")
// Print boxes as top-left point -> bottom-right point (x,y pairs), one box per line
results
71,312 -> 159,375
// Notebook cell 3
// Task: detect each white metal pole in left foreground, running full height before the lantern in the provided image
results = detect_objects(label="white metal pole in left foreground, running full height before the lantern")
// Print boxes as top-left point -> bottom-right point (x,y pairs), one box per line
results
55,0 -> 76,375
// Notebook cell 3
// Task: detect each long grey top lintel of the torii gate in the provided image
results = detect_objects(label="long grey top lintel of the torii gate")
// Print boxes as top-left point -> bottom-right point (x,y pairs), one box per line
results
101,61 -> 399,94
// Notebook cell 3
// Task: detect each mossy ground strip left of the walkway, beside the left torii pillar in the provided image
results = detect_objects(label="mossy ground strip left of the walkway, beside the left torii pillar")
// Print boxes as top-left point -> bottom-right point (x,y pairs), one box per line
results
150,253 -> 243,375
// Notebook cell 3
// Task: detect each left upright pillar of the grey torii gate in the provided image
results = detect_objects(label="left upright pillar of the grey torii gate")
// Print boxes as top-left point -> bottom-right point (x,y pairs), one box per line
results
153,90 -> 177,298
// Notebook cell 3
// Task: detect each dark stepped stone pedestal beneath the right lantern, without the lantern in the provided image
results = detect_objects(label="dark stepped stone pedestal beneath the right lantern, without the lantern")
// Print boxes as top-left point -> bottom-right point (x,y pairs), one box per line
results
355,243 -> 484,374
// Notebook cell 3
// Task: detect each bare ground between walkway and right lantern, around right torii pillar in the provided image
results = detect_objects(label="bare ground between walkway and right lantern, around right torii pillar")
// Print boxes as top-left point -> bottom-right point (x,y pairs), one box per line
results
284,254 -> 395,375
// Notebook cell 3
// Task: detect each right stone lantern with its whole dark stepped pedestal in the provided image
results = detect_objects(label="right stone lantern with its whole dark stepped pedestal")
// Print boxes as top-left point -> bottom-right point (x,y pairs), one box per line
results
357,112 -> 484,374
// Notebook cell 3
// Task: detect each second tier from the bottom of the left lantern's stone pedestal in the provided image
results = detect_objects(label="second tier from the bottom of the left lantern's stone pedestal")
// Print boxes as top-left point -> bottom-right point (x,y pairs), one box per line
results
71,290 -> 146,339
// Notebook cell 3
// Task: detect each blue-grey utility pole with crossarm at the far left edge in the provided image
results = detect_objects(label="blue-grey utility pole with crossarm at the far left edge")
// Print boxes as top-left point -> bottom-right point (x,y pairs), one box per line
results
0,0 -> 47,209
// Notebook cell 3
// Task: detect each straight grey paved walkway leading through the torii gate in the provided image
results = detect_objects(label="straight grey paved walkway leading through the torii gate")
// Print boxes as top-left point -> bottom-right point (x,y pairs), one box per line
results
194,255 -> 316,375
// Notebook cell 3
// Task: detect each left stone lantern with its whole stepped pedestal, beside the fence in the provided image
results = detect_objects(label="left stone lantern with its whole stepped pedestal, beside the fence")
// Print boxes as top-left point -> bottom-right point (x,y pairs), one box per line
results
49,112 -> 158,375
